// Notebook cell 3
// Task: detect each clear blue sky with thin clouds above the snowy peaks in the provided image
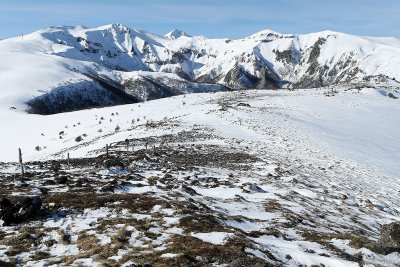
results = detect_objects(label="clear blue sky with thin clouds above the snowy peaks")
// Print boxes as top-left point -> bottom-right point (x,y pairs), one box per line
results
0,0 -> 400,38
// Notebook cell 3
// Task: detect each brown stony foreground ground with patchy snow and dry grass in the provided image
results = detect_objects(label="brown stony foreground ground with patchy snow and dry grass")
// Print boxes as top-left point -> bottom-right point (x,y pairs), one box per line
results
0,89 -> 400,266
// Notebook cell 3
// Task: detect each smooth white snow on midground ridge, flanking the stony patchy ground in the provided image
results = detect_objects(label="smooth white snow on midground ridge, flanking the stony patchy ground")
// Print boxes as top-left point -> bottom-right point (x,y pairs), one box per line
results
0,89 -> 400,178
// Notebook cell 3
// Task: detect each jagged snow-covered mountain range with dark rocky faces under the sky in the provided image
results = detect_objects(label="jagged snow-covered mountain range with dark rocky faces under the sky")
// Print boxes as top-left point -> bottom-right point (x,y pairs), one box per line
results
0,24 -> 400,114
